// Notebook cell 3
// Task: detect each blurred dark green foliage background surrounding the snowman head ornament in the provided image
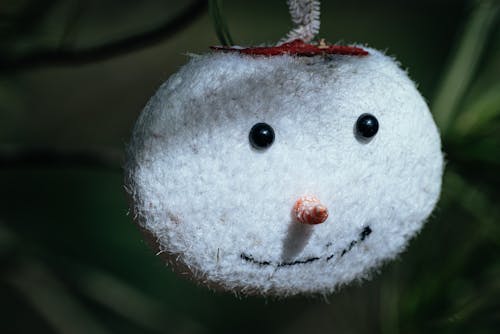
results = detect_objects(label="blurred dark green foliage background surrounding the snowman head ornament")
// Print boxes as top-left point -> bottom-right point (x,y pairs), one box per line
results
0,0 -> 500,333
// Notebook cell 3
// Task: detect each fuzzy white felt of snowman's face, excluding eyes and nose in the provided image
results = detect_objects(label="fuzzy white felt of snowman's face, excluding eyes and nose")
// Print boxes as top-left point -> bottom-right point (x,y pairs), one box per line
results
126,48 -> 443,296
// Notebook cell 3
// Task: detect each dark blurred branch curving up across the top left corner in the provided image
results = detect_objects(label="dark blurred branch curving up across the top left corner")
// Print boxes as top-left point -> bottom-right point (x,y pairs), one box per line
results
0,0 -> 207,71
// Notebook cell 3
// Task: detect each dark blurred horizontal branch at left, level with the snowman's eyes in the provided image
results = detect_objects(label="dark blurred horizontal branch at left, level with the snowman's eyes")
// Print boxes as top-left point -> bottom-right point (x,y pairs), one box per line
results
0,147 -> 123,171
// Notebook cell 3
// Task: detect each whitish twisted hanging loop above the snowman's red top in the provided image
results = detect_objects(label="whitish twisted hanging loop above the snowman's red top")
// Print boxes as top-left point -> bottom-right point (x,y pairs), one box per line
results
280,0 -> 320,44
